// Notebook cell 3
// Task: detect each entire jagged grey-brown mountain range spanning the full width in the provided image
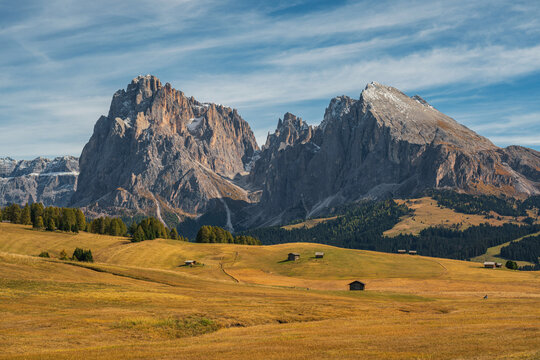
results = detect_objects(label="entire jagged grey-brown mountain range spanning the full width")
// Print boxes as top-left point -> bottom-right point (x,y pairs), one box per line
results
0,75 -> 540,230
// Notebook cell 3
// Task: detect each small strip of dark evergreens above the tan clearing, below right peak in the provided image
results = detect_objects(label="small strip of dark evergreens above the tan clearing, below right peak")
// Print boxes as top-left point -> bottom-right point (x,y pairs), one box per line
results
426,190 -> 527,216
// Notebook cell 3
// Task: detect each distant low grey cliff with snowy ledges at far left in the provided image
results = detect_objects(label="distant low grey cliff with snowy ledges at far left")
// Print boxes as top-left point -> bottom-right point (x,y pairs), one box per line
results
0,156 -> 79,206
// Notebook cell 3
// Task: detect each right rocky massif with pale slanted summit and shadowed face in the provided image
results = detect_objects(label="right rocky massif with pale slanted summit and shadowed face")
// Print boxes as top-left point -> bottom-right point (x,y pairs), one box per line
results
244,83 -> 540,226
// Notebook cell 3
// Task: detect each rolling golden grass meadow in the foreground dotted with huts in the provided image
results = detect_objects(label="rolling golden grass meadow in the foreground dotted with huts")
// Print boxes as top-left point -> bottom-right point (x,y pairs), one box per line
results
0,224 -> 540,360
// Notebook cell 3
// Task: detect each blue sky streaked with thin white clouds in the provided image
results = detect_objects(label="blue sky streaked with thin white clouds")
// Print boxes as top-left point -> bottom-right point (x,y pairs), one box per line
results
0,0 -> 540,159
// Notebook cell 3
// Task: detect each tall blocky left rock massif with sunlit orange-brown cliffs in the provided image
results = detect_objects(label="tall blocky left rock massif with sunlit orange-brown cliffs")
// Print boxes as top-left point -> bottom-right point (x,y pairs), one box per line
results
72,75 -> 258,228
